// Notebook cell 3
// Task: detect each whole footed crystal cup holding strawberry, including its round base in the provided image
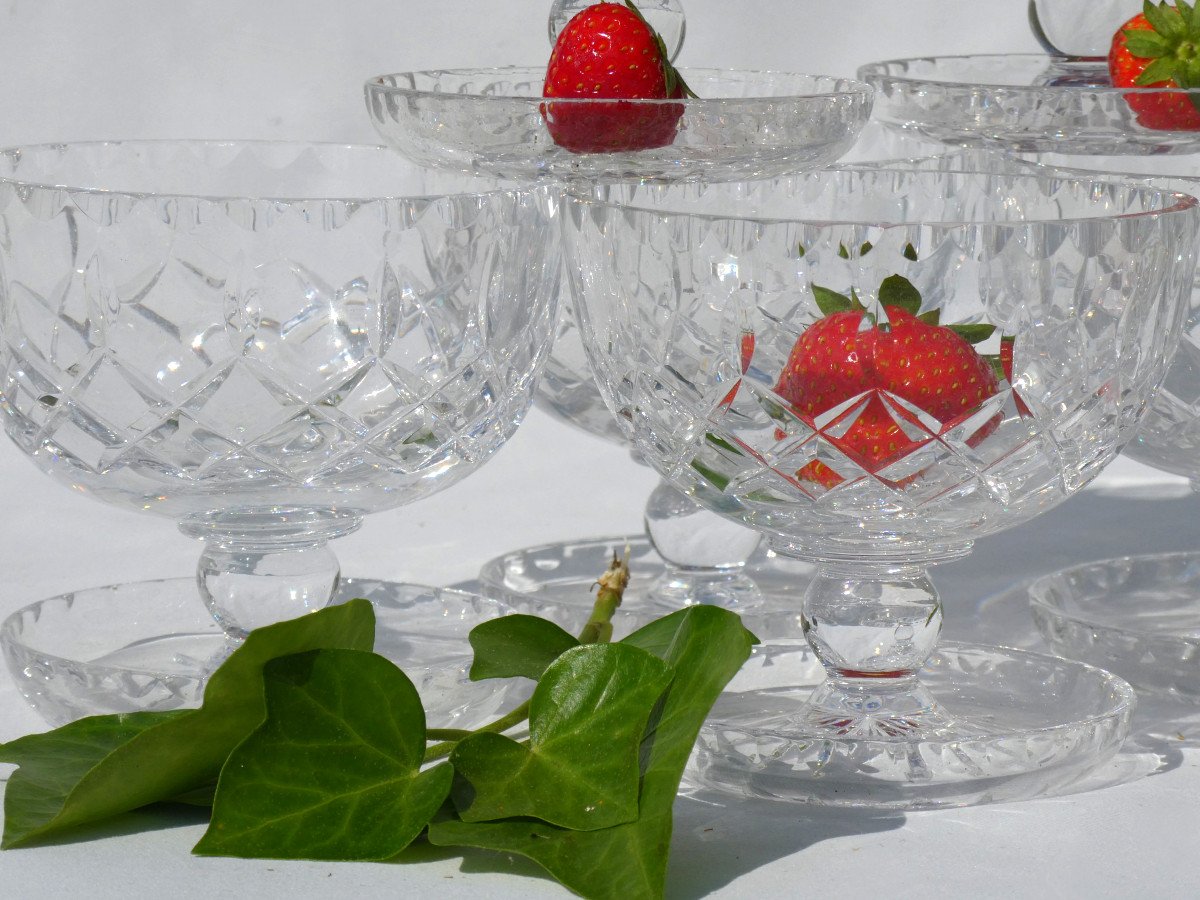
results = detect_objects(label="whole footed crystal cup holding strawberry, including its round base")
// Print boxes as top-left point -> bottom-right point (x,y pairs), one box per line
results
563,167 -> 1200,809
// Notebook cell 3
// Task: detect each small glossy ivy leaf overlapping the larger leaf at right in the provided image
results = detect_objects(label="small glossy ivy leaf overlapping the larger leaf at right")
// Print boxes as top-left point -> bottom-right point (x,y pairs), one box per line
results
450,643 -> 672,830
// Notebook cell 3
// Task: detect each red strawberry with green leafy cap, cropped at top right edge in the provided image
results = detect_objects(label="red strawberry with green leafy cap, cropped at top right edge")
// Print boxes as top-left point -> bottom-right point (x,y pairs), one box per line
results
1109,0 -> 1200,131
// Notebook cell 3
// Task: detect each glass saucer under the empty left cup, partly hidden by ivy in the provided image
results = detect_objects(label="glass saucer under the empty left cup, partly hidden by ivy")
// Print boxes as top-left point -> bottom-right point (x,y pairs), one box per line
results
0,578 -> 529,728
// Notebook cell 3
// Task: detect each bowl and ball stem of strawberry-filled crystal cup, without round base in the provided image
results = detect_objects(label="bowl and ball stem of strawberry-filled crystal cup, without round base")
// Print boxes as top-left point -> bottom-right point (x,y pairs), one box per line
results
563,167 -> 1200,748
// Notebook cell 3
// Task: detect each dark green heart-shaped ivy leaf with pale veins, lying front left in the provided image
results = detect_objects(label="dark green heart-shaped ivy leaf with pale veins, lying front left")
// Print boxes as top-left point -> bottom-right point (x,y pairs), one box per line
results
193,650 -> 454,860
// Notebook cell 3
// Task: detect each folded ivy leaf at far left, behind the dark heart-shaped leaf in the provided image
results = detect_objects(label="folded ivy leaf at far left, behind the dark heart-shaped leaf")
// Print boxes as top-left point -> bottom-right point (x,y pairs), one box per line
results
0,600 -> 374,848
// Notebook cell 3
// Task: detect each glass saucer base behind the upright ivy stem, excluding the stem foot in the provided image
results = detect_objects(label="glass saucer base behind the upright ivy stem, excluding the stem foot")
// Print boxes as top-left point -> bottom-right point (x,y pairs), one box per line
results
479,535 -> 812,637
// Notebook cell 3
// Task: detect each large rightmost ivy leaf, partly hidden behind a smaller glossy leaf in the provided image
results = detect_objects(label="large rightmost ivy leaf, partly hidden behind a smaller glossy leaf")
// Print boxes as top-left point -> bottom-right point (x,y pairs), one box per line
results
430,606 -> 756,900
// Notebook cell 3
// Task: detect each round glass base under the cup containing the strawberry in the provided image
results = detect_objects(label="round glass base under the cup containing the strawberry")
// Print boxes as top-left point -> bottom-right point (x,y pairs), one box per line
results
688,641 -> 1135,810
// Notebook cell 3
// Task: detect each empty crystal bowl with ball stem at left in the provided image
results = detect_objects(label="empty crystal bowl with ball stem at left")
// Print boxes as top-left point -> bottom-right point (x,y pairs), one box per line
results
0,142 -> 559,637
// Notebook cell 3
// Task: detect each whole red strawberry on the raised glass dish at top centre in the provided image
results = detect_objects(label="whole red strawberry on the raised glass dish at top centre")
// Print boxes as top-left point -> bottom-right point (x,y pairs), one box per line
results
542,0 -> 695,154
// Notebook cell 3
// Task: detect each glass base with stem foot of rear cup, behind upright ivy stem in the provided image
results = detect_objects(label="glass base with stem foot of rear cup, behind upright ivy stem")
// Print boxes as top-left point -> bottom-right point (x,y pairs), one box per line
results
479,535 -> 814,636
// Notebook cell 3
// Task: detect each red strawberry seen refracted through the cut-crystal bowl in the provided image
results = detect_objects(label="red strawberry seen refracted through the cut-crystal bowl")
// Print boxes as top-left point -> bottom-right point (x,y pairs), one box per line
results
775,282 -> 1000,488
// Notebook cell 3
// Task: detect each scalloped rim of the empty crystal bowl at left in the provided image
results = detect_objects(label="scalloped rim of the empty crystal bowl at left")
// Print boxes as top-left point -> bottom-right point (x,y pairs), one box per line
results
0,138 -> 516,205
